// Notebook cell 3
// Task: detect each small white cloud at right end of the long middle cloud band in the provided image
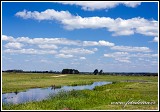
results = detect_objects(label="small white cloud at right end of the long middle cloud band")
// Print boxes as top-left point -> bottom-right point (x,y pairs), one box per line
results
83,40 -> 114,46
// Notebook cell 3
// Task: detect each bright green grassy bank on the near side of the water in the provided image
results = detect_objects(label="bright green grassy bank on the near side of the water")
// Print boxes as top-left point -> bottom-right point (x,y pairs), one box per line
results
2,82 -> 158,110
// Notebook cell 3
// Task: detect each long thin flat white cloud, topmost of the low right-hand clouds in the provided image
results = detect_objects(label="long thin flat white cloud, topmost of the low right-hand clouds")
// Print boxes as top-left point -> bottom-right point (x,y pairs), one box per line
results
111,46 -> 151,52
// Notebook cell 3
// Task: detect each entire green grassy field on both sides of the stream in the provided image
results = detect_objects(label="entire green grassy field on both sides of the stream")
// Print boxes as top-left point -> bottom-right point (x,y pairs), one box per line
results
2,73 -> 158,110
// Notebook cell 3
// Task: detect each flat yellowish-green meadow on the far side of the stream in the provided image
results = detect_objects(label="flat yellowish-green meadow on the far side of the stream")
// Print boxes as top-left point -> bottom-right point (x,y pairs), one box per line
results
2,73 -> 158,93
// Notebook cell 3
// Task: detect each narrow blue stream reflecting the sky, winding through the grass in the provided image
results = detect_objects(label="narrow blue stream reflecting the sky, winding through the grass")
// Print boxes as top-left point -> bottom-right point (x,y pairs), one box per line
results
2,82 -> 112,104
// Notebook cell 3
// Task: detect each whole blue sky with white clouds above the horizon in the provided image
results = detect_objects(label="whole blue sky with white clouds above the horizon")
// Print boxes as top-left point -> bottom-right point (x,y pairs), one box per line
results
1,1 -> 159,72
